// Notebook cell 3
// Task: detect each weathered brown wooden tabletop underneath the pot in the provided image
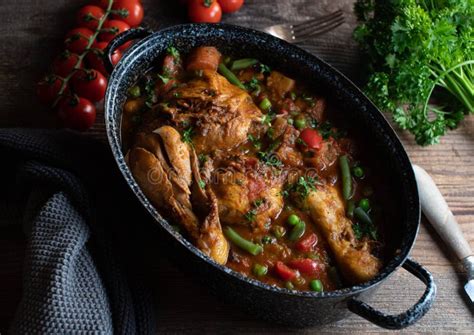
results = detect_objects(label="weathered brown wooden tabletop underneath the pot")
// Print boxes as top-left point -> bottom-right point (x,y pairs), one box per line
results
0,0 -> 474,334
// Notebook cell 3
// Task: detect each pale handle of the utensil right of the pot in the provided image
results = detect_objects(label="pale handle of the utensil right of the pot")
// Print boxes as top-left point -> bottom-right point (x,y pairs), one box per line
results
413,165 -> 472,260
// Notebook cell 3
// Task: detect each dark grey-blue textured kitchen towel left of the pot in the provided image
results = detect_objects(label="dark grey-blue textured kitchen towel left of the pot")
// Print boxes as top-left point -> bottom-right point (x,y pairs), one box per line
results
0,129 -> 155,334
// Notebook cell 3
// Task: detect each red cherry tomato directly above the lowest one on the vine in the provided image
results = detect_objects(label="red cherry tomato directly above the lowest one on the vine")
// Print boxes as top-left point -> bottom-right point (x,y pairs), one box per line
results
72,70 -> 107,102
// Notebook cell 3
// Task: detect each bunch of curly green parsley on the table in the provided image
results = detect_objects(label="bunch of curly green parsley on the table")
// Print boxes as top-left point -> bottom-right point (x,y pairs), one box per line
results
354,0 -> 474,145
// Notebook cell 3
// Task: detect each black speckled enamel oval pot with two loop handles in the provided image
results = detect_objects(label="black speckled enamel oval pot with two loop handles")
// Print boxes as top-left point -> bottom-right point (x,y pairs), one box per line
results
105,24 -> 436,329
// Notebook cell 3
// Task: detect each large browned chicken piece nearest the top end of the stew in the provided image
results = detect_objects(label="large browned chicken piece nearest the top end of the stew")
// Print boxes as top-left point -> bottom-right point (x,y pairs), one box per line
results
167,70 -> 262,153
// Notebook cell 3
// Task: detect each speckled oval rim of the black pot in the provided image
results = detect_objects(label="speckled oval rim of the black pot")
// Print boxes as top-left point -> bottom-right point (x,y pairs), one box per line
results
104,24 -> 421,299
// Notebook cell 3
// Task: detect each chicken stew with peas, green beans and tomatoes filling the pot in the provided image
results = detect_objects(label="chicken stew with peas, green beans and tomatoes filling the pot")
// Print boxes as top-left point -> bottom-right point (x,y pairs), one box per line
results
122,47 -> 384,292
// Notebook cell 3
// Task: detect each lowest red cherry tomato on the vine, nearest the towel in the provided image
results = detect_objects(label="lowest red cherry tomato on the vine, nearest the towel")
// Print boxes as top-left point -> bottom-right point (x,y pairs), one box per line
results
58,96 -> 96,131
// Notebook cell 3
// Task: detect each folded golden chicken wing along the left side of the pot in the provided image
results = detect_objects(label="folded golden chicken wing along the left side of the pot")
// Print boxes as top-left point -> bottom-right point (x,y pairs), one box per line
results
128,126 -> 229,264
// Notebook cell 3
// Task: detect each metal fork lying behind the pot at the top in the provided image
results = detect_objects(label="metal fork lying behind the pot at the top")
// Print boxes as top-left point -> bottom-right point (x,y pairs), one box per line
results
262,9 -> 344,43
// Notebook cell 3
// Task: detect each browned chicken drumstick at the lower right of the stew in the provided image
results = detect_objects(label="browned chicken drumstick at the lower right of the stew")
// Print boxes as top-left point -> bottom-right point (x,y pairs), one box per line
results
306,185 -> 382,284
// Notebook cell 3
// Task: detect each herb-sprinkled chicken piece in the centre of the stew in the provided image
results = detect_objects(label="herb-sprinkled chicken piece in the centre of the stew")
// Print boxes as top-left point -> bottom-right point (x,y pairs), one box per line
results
213,161 -> 284,232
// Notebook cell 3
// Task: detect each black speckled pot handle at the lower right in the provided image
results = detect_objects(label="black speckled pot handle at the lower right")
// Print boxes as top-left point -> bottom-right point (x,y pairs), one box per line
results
347,258 -> 436,329
